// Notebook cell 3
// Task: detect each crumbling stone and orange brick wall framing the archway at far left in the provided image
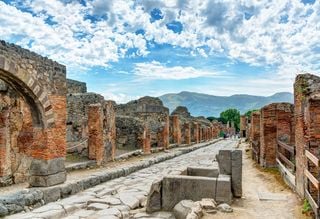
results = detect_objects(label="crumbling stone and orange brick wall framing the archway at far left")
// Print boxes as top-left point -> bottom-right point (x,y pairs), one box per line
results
0,41 -> 67,186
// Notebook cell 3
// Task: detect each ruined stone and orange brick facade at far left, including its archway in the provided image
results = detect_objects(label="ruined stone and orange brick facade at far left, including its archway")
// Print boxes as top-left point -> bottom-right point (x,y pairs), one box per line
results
0,41 -> 67,186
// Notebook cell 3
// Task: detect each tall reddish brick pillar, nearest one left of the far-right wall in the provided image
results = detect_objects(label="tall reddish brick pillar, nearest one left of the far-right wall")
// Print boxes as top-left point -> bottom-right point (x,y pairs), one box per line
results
260,104 -> 277,167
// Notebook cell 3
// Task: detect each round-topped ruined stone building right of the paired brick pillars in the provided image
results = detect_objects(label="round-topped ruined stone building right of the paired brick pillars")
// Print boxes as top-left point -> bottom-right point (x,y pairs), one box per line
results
116,97 -> 169,151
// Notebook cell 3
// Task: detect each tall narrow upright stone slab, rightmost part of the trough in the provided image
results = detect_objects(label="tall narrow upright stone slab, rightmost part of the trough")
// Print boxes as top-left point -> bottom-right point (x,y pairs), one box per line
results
231,150 -> 242,198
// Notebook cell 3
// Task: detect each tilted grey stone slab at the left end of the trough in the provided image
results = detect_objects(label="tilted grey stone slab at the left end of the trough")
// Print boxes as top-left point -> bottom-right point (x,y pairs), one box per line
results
146,179 -> 162,213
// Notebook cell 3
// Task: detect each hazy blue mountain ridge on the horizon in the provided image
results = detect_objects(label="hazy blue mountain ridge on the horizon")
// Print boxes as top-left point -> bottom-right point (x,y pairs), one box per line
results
159,91 -> 293,117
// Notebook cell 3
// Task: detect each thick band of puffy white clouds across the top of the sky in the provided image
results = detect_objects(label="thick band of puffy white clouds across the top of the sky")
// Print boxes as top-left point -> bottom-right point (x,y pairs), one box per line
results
0,0 -> 320,77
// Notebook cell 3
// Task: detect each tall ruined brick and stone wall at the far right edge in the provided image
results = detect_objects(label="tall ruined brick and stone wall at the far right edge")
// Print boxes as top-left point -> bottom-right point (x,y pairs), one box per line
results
294,74 -> 320,198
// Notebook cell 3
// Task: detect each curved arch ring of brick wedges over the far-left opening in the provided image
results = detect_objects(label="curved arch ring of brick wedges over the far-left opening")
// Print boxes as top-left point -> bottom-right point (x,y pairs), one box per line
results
0,57 -> 55,127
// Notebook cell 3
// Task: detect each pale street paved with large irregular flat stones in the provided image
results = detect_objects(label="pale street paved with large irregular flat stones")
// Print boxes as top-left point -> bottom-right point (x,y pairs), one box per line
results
7,140 -> 238,219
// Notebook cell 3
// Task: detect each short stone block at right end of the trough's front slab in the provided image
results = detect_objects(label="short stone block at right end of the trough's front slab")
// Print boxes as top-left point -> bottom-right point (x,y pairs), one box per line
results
215,174 -> 232,204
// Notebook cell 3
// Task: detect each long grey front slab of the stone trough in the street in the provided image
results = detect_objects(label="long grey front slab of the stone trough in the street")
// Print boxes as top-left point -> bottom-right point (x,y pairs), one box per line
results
162,175 -> 217,211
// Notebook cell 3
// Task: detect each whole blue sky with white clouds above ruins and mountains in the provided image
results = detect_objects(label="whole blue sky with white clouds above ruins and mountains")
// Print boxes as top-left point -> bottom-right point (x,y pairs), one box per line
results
0,0 -> 320,102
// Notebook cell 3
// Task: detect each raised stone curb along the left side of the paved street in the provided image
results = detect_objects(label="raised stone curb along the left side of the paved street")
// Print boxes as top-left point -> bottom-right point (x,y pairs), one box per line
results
0,139 -> 221,217
